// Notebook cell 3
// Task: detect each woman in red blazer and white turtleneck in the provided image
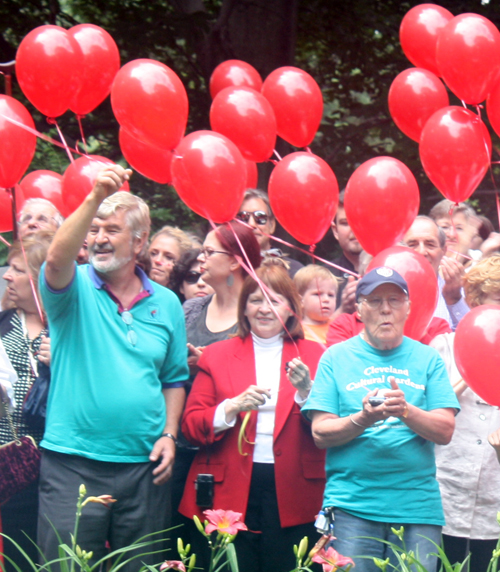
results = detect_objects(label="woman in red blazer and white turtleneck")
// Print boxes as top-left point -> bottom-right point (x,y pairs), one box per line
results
179,260 -> 325,572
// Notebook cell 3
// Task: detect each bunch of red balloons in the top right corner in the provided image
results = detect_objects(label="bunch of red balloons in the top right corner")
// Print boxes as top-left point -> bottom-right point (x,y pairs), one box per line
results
389,4 -> 500,202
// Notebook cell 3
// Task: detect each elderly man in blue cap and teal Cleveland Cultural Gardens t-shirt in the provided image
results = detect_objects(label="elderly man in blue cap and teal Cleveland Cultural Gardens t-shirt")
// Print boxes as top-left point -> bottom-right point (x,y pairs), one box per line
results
302,267 -> 459,572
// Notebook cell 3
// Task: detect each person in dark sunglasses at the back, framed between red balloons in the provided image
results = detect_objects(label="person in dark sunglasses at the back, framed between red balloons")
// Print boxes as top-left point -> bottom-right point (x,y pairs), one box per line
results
236,189 -> 303,278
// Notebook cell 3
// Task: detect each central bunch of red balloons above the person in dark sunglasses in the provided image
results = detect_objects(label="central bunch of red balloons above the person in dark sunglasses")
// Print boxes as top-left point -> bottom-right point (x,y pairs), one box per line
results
171,60 -> 332,232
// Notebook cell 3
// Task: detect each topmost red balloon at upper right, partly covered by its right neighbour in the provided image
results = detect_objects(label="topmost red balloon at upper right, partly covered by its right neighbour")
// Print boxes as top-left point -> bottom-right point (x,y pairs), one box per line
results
399,4 -> 453,75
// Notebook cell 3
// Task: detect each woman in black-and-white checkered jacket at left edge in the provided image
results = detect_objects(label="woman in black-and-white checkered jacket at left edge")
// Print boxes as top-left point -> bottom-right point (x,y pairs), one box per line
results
0,231 -> 53,572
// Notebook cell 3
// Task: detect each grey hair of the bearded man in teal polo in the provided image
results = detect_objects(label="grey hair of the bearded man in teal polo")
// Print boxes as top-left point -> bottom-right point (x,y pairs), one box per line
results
95,191 -> 151,257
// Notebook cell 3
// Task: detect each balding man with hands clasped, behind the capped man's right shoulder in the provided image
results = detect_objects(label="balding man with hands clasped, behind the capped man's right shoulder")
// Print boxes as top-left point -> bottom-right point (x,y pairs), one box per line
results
404,215 -> 469,330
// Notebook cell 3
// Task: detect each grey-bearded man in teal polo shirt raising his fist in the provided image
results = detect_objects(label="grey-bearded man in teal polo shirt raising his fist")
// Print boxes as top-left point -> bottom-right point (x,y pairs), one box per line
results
38,166 -> 189,572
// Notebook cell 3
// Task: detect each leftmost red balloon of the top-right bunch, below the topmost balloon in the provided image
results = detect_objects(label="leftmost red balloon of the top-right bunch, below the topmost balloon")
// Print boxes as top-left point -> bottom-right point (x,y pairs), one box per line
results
389,68 -> 450,143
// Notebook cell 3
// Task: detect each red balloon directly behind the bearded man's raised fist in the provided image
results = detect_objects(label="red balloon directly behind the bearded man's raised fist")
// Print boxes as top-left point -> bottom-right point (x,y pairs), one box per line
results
62,155 -> 130,216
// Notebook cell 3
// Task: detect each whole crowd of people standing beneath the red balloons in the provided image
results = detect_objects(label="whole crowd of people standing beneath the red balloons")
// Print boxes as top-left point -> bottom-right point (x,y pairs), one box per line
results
0,166 -> 500,572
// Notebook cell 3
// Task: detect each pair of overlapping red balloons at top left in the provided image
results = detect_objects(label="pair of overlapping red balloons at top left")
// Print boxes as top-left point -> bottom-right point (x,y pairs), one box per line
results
16,24 -> 120,117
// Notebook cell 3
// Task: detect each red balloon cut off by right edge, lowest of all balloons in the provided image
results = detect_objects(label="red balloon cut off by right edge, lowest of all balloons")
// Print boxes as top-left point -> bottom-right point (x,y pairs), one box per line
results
453,305 -> 500,406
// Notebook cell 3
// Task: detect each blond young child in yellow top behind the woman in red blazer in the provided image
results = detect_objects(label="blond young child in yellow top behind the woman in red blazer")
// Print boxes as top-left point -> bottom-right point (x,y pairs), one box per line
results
293,264 -> 338,344
